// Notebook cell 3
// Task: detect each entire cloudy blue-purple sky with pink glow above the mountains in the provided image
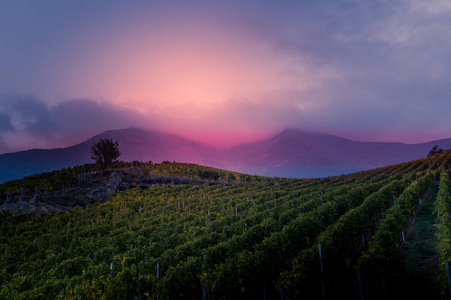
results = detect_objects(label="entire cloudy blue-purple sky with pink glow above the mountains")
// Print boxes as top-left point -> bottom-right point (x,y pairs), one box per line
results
0,0 -> 451,153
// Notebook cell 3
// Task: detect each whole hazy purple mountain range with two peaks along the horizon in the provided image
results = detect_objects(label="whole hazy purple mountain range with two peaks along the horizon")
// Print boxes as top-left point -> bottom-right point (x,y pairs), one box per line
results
0,128 -> 451,182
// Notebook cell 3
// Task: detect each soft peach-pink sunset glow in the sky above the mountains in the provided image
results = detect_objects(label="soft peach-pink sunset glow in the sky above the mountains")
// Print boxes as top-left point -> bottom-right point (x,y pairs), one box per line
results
64,14 -> 313,129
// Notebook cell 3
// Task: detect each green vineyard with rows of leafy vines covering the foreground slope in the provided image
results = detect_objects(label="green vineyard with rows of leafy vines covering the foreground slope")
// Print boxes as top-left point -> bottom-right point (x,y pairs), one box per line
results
0,152 -> 451,299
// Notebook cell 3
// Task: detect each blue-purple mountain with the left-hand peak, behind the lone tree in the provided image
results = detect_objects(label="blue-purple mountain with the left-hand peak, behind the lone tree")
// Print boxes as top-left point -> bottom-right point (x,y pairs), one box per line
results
0,128 -> 216,182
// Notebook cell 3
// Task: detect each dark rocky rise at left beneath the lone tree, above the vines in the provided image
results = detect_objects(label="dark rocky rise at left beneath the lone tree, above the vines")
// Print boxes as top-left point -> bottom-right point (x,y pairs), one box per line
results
0,161 -> 252,213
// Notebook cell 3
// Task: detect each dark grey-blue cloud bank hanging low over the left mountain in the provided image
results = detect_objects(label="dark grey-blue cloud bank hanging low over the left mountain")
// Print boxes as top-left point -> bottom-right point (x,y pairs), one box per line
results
0,95 -> 150,151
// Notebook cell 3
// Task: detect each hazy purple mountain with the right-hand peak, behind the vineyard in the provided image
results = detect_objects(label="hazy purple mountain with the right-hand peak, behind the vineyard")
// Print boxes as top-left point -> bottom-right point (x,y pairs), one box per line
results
230,129 -> 451,177
